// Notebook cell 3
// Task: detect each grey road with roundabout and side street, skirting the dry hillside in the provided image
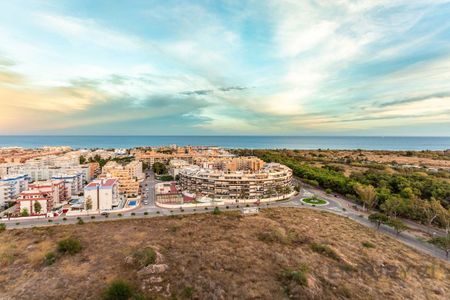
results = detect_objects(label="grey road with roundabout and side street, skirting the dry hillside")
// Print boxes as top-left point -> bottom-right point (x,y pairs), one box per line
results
1,172 -> 448,260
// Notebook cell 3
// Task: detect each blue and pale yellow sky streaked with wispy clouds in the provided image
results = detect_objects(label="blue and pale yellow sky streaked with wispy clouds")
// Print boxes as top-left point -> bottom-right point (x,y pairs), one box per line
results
0,0 -> 450,136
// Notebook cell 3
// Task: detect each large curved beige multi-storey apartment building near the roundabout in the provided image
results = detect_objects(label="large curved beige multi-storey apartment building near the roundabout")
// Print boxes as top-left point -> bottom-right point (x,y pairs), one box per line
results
179,163 -> 293,200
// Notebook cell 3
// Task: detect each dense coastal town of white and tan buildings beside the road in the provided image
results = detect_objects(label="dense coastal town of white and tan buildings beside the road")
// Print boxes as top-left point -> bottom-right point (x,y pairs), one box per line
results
0,145 -> 297,224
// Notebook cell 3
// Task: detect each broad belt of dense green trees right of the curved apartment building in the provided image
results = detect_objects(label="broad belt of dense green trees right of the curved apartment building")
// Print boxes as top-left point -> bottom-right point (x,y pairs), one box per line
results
241,150 -> 450,228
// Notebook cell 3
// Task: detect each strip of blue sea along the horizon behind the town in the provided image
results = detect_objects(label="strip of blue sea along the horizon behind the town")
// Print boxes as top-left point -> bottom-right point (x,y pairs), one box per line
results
0,135 -> 450,150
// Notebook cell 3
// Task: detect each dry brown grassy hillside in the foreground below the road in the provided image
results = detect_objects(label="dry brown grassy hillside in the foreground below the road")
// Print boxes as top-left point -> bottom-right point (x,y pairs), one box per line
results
0,208 -> 450,299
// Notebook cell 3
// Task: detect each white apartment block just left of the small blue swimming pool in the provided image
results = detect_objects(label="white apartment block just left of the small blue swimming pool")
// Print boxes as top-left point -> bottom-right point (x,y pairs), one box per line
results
84,178 -> 120,211
